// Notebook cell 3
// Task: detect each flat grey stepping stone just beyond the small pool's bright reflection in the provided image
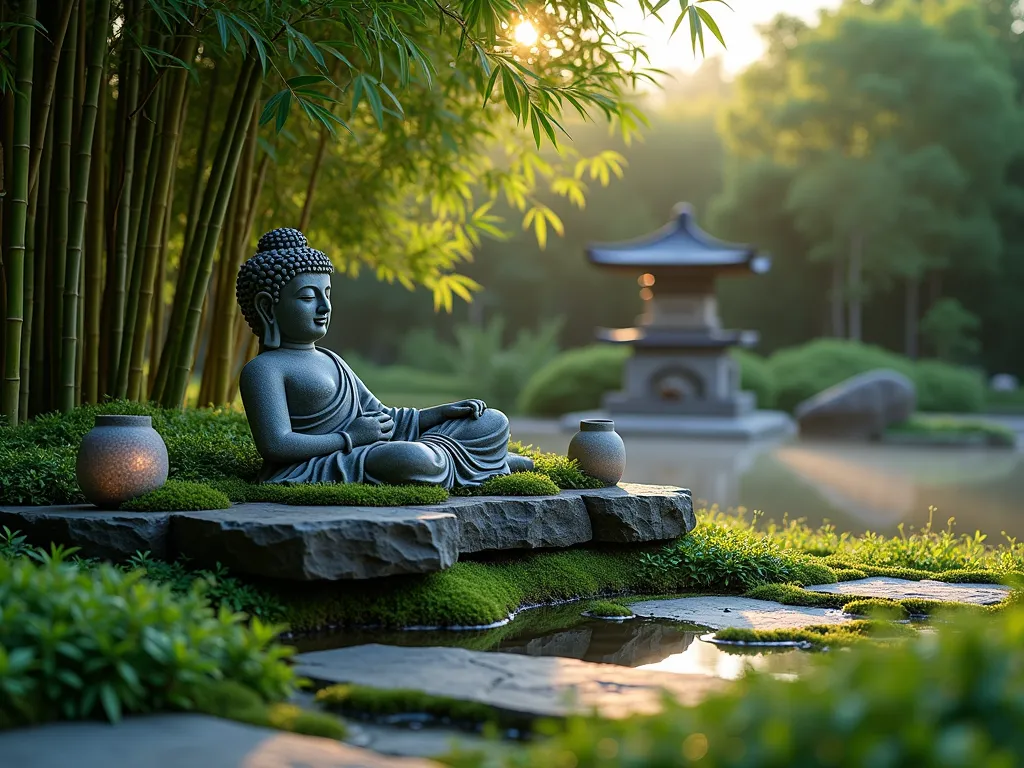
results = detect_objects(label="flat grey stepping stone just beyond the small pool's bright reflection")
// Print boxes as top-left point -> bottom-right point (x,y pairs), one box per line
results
630,597 -> 850,630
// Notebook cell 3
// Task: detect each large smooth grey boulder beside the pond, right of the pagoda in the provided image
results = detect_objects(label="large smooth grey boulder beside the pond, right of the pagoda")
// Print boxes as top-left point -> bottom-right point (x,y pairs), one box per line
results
794,369 -> 918,440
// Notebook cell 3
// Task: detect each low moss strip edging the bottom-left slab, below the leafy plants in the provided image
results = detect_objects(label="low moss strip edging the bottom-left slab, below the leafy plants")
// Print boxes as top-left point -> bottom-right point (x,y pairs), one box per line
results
193,680 -> 347,740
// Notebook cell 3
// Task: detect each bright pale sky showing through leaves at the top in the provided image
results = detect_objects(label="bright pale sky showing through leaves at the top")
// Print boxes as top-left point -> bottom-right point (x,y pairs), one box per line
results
615,0 -> 841,74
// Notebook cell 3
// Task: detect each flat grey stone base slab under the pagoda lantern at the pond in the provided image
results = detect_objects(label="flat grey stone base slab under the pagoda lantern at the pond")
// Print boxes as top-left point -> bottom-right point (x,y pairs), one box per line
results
560,411 -> 797,440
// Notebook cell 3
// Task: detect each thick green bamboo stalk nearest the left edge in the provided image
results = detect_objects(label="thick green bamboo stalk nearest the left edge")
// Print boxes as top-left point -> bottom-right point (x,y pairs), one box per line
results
0,0 -> 36,425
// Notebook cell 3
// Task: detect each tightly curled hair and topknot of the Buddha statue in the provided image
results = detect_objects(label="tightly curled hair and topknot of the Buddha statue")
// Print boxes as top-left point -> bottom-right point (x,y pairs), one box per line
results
234,227 -> 334,335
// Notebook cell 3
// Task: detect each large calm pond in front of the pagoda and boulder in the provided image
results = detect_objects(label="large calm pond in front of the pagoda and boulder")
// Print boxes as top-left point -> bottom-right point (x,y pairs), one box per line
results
513,420 -> 1024,540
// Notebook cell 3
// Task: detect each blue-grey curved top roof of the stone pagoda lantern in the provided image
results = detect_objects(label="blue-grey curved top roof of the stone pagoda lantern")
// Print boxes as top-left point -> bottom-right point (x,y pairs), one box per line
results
587,203 -> 771,274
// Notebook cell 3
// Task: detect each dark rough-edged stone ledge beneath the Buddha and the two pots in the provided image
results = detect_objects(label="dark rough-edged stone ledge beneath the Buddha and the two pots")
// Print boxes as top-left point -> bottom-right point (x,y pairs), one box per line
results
0,483 -> 696,581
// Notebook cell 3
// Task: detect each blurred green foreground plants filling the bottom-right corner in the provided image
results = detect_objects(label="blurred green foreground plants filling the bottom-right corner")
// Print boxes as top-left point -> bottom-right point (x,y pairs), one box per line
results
444,609 -> 1024,768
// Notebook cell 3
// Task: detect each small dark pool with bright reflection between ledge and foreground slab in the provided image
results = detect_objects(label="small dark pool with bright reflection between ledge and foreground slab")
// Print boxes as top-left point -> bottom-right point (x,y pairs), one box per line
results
292,602 -> 809,680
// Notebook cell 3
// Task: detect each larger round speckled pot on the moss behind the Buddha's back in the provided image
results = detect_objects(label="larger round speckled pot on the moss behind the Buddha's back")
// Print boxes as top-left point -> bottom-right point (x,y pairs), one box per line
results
75,416 -> 167,507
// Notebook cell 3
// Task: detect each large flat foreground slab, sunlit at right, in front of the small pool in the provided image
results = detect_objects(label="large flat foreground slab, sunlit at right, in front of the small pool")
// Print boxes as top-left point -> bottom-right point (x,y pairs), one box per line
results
295,645 -> 724,718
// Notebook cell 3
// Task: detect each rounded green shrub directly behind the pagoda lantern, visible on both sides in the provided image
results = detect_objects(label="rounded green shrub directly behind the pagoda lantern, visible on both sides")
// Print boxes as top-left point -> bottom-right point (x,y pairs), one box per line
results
519,344 -> 775,416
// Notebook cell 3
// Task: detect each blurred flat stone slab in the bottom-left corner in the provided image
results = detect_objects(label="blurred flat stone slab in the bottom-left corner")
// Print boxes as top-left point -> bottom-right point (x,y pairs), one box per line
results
0,715 -> 439,768
